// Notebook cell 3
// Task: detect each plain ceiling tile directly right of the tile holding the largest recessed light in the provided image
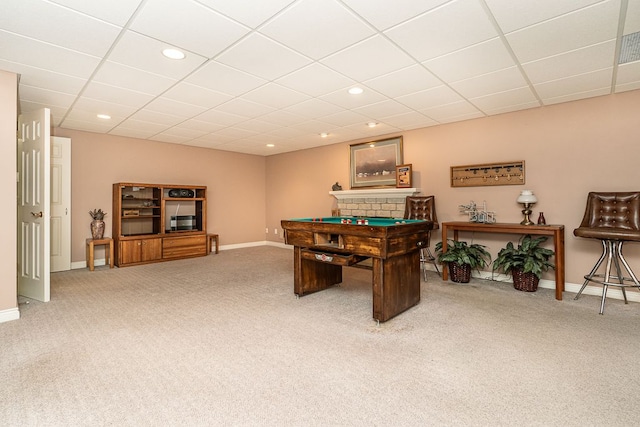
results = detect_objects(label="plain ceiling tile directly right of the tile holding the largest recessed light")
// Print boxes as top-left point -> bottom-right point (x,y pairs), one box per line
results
185,61 -> 267,96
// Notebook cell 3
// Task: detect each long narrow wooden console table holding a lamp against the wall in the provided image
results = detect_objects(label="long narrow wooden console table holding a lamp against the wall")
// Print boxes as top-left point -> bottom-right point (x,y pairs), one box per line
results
441,221 -> 564,301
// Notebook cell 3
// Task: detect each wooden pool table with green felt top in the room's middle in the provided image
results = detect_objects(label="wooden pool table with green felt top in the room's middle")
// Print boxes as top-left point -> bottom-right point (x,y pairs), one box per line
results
281,217 -> 433,322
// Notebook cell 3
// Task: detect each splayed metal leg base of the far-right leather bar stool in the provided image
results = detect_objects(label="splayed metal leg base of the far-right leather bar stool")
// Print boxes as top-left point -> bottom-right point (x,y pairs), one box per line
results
574,240 -> 640,314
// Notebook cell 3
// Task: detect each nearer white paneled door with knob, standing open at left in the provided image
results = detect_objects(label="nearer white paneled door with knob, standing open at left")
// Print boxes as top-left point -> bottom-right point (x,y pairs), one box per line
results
18,108 -> 51,302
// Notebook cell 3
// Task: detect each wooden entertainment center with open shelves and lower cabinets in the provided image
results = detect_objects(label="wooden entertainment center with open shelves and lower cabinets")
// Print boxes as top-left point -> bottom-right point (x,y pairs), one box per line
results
113,182 -> 207,267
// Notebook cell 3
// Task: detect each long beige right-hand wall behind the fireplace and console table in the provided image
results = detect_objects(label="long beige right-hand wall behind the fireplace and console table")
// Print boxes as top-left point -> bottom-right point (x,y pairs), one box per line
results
266,90 -> 640,283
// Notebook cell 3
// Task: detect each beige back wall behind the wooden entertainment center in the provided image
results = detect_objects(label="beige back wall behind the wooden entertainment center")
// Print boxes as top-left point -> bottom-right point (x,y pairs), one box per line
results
54,129 -> 265,262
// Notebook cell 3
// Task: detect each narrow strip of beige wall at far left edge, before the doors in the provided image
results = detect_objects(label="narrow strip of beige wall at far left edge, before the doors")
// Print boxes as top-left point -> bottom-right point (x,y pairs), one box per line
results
0,71 -> 18,321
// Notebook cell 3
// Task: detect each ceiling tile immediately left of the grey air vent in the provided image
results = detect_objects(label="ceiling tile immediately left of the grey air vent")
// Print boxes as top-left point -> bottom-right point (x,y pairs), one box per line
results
522,40 -> 616,83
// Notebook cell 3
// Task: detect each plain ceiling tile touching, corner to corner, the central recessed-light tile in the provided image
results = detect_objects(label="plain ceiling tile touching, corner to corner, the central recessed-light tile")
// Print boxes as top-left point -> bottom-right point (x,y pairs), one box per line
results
321,35 -> 415,81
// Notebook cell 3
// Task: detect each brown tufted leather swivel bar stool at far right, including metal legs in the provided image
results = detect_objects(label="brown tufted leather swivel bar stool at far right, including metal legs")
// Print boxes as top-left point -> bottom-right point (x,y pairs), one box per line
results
573,192 -> 640,314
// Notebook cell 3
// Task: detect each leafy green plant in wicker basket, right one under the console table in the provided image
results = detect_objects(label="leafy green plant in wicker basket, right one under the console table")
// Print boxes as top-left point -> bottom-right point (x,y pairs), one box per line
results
493,234 -> 555,292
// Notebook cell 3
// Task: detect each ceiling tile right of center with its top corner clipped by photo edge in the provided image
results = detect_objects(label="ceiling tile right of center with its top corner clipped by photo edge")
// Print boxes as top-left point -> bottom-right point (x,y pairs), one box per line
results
385,0 -> 498,61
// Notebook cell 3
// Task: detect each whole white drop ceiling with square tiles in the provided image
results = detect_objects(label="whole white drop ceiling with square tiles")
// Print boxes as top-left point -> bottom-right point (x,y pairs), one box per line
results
0,0 -> 640,156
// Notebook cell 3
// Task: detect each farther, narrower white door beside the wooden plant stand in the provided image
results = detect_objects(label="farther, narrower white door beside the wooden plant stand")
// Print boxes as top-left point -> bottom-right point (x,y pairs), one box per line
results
49,136 -> 71,273
